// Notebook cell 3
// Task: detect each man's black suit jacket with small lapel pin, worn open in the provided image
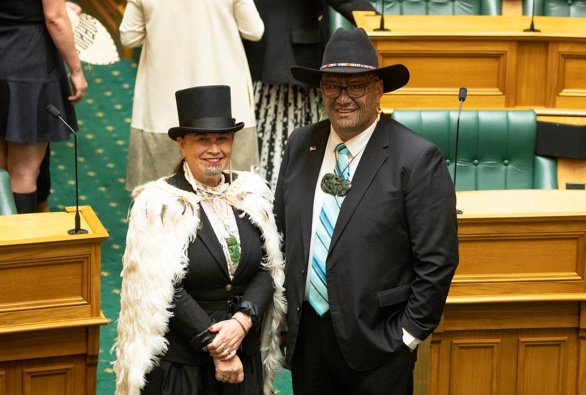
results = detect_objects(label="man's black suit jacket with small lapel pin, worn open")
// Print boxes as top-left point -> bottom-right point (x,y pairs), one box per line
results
275,115 -> 458,370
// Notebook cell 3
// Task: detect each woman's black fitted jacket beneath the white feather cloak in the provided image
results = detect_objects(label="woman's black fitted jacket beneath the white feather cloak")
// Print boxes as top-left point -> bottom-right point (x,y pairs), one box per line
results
162,171 -> 274,364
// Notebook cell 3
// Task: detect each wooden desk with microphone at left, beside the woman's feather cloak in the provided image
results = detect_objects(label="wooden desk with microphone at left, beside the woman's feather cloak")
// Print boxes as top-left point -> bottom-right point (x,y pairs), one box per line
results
0,207 -> 108,395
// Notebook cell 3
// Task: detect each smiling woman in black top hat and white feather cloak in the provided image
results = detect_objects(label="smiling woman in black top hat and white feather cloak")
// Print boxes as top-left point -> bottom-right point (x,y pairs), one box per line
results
114,85 -> 286,395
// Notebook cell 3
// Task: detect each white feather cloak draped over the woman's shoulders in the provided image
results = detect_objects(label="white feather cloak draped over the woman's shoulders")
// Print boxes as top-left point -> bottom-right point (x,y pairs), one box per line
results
112,172 -> 286,395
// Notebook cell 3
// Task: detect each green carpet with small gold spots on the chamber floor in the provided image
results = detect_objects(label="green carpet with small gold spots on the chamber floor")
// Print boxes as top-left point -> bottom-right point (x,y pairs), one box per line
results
49,60 -> 292,395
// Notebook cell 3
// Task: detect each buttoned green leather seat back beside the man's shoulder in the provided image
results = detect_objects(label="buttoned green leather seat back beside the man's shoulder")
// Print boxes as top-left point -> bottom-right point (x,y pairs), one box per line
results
392,110 -> 557,191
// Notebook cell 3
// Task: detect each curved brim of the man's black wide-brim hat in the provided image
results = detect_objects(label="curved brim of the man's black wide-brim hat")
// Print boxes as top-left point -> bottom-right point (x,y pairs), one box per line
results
291,64 -> 409,93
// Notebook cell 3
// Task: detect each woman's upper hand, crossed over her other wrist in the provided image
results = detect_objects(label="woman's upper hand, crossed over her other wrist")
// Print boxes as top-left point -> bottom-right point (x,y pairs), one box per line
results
207,311 -> 252,361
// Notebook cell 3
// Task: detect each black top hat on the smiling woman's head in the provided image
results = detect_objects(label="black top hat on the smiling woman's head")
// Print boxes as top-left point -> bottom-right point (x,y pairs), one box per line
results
169,85 -> 244,140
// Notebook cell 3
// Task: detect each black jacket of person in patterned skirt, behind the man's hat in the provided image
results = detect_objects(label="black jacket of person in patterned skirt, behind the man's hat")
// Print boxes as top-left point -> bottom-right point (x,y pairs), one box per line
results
243,0 -> 375,85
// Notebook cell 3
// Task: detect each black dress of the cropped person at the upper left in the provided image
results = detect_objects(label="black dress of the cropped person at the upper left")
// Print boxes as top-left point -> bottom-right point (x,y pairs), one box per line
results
0,0 -> 78,144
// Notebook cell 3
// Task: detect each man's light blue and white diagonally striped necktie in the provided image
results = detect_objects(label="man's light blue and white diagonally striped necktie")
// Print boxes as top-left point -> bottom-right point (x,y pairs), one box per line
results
309,143 -> 350,316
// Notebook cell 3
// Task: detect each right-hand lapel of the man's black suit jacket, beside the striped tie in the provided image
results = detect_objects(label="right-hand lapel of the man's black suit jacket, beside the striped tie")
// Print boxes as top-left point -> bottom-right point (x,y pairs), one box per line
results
330,115 -> 389,251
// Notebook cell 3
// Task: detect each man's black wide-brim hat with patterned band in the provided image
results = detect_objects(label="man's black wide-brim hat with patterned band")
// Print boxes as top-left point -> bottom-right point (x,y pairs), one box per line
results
291,28 -> 409,93
